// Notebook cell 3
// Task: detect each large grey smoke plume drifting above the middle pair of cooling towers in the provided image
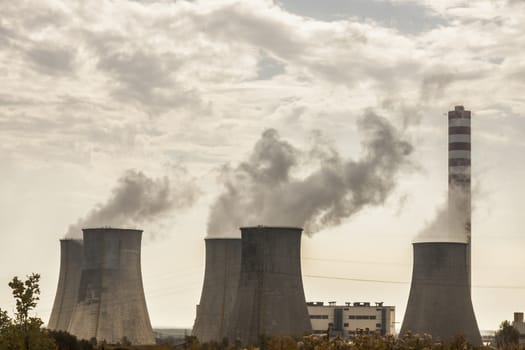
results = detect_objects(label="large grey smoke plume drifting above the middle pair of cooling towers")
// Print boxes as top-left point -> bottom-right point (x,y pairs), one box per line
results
208,112 -> 412,237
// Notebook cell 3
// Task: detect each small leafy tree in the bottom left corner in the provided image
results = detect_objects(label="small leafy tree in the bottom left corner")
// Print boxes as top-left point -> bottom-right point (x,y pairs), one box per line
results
0,273 -> 56,350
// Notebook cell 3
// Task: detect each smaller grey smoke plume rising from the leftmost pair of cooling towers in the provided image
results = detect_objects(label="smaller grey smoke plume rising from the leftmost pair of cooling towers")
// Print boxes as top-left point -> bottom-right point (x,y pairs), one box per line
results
66,170 -> 198,238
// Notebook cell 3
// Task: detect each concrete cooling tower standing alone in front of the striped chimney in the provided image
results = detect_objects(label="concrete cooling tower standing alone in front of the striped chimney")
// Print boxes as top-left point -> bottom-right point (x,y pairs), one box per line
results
400,242 -> 481,345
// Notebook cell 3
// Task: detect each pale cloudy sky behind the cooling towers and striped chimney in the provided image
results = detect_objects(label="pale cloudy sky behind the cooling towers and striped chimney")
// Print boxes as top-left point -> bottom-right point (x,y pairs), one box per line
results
0,0 -> 525,329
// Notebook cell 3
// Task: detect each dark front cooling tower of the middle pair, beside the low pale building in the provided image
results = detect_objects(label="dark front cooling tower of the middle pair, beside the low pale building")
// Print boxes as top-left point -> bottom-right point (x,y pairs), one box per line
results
227,226 -> 312,345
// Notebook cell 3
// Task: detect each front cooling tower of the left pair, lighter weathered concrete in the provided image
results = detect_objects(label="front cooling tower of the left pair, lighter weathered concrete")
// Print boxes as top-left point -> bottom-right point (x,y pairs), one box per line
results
68,228 -> 155,344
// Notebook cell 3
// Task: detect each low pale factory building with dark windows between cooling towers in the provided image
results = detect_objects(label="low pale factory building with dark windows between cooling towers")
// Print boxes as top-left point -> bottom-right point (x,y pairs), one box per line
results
307,302 -> 396,338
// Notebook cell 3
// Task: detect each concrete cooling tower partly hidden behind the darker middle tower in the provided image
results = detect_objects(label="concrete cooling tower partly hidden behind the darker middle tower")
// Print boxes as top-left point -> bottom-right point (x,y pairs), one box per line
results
192,238 -> 241,342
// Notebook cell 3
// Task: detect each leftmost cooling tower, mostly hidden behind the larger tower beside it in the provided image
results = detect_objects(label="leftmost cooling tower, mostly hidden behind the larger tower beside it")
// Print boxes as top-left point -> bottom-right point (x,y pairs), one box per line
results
47,239 -> 84,331
